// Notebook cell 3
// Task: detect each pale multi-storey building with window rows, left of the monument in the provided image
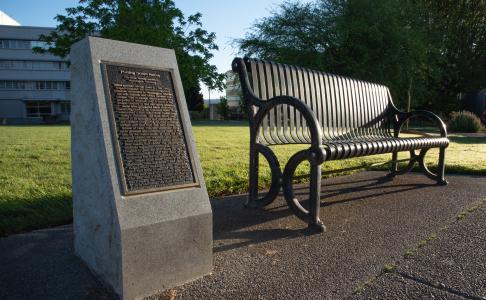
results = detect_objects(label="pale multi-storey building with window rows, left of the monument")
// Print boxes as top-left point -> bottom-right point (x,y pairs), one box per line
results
0,13 -> 71,124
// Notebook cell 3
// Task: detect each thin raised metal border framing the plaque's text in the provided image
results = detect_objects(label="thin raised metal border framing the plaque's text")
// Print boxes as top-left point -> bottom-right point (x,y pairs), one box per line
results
99,60 -> 201,196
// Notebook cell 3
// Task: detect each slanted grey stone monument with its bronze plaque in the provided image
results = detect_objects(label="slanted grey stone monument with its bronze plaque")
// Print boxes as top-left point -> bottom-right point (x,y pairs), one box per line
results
70,37 -> 212,299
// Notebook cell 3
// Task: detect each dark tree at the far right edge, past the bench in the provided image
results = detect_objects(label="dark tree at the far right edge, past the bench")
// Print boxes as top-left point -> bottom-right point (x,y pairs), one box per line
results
420,0 -> 486,111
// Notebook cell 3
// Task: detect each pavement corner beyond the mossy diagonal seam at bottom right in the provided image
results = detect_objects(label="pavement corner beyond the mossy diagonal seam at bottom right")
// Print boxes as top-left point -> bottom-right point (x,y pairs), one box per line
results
353,202 -> 486,299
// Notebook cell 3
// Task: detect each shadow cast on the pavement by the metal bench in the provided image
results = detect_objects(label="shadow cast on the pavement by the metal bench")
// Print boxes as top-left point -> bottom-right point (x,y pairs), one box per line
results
211,175 -> 435,253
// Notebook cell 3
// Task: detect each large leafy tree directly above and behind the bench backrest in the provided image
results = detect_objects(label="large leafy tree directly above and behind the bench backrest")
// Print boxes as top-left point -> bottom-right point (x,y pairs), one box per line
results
237,0 -> 428,107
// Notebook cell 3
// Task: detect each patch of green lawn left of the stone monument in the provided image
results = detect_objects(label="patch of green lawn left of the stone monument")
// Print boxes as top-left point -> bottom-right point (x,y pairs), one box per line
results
0,126 -> 72,235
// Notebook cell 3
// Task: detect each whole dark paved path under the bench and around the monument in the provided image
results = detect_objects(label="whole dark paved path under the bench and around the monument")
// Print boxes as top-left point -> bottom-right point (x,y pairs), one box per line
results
0,172 -> 486,299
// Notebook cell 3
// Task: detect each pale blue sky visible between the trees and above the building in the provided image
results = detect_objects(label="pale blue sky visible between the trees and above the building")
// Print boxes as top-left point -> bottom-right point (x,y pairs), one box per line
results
0,0 -> 309,99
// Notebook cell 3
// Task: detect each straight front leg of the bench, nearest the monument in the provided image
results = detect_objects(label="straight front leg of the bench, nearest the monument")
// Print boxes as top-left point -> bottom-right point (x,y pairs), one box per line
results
308,163 -> 326,232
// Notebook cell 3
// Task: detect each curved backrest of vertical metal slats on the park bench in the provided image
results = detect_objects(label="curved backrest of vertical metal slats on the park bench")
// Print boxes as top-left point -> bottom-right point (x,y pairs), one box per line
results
237,58 -> 391,144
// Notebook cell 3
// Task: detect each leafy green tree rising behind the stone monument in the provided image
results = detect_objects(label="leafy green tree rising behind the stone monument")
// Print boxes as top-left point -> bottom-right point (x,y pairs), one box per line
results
34,0 -> 224,110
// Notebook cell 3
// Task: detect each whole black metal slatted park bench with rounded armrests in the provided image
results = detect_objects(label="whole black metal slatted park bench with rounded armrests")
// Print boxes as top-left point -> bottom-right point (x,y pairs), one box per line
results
232,58 -> 449,231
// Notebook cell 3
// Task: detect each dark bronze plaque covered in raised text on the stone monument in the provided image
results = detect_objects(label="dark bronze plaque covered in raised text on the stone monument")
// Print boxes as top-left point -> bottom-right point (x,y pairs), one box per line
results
102,63 -> 197,195
